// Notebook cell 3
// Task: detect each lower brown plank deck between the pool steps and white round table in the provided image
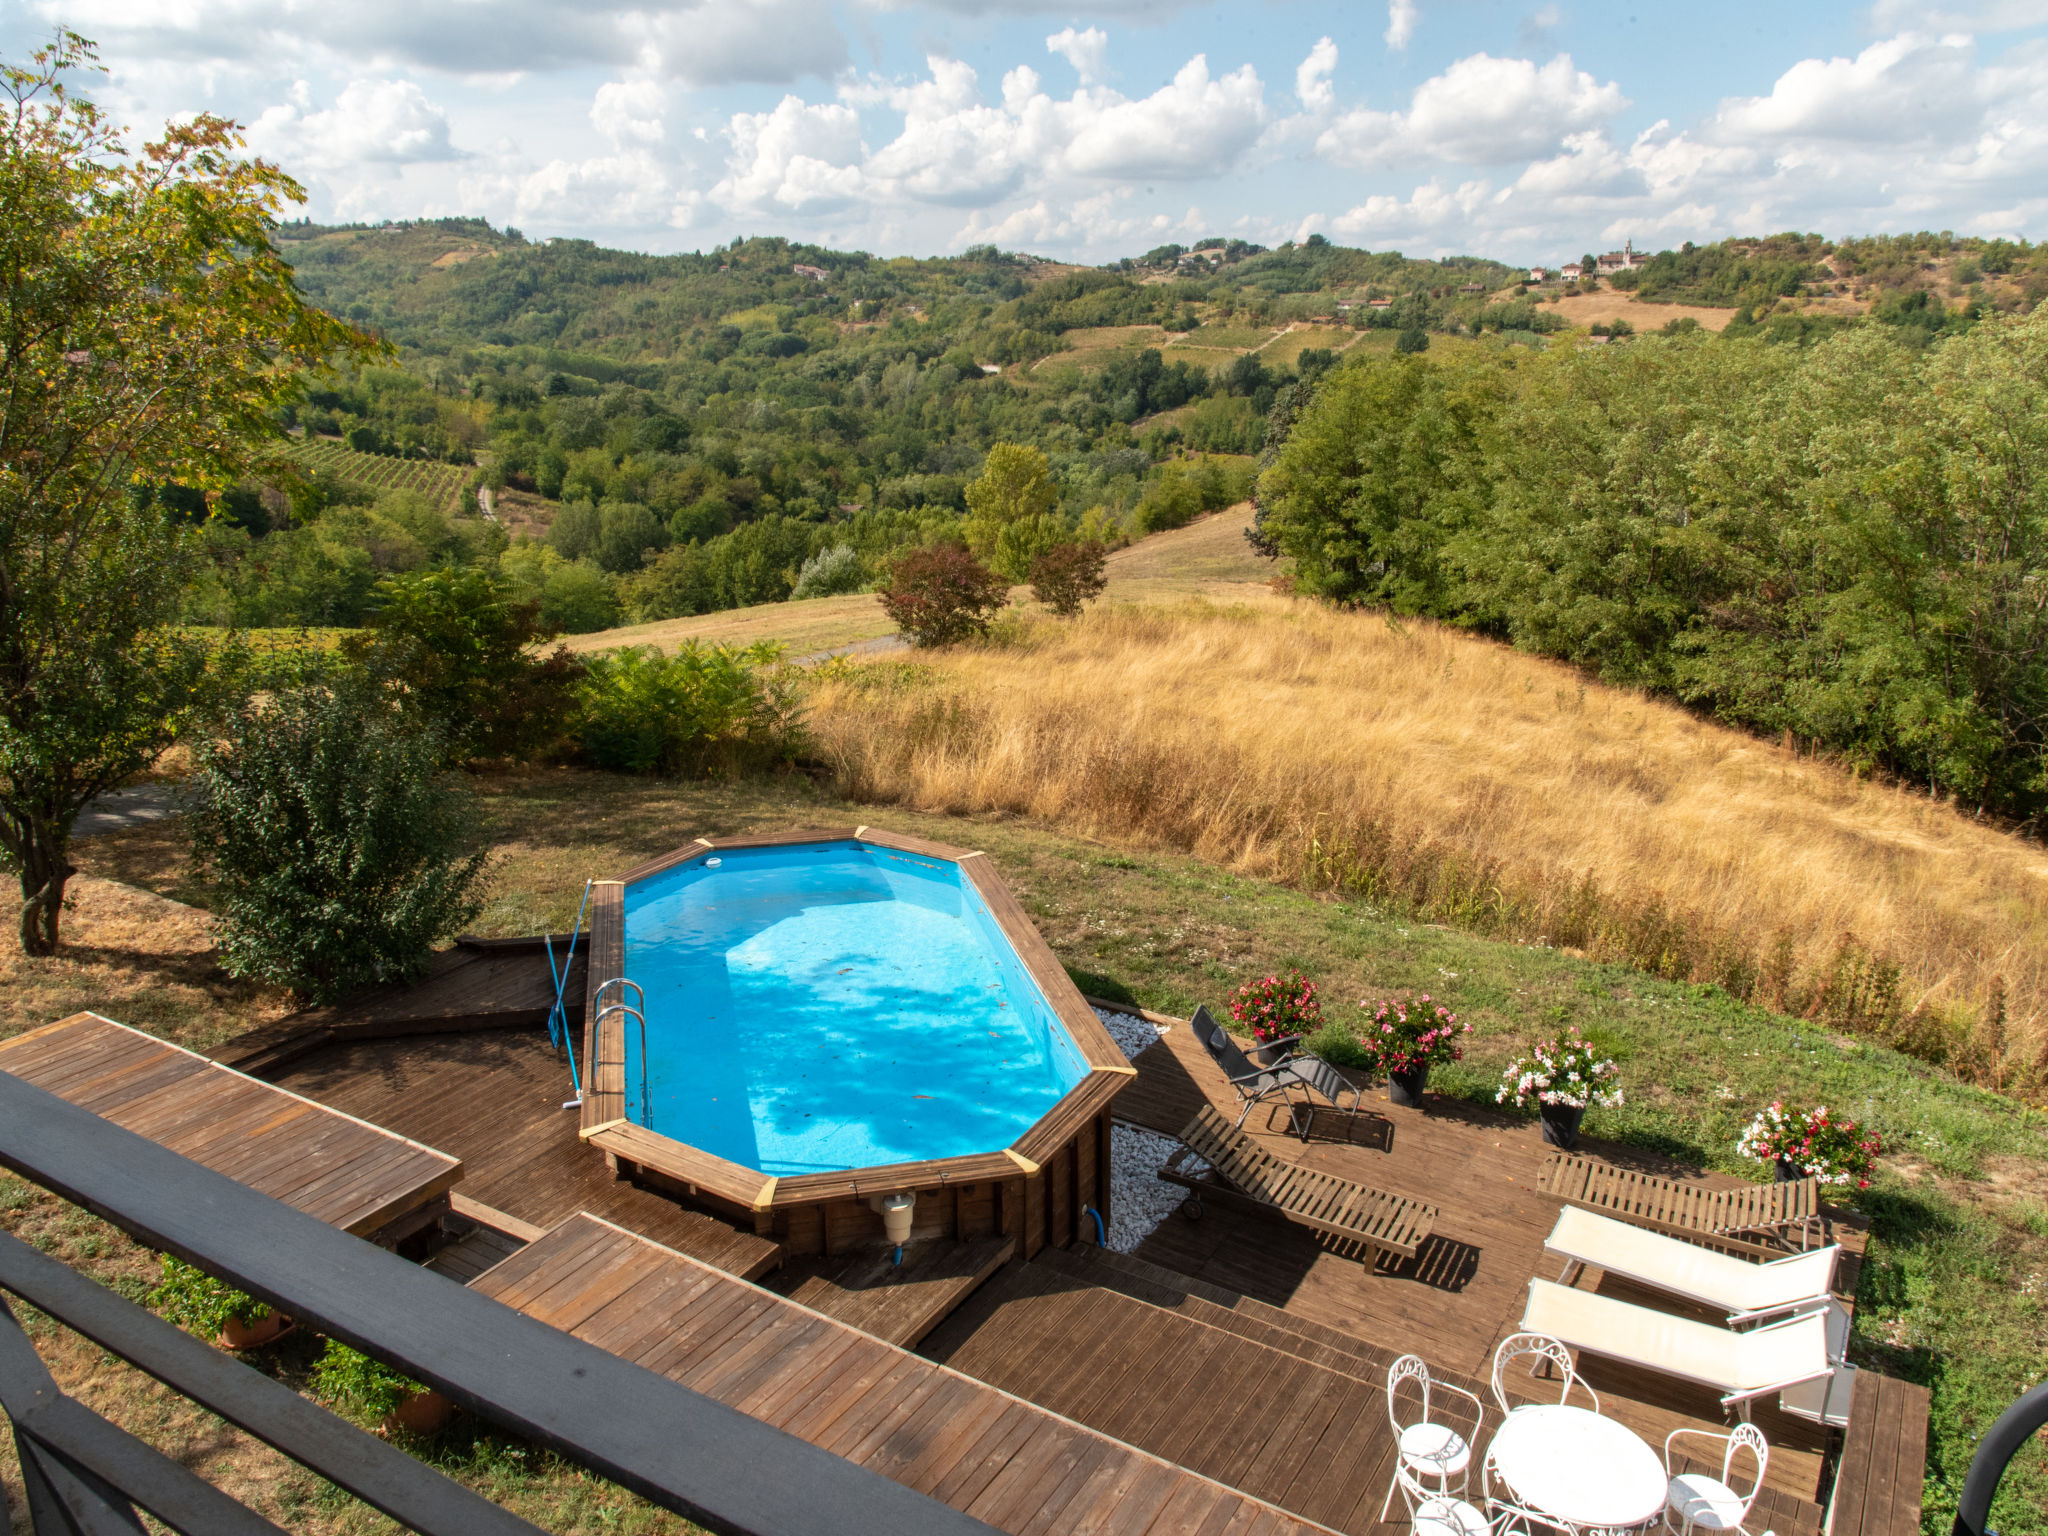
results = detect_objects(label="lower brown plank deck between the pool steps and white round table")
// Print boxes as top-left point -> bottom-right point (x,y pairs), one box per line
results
926,1249 -> 1821,1536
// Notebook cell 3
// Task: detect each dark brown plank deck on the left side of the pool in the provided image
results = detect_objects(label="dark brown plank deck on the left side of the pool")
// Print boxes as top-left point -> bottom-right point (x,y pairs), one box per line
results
276,1028 -> 782,1280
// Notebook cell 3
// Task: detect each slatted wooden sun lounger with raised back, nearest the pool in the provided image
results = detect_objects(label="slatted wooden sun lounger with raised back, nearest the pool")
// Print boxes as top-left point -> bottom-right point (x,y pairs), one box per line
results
1159,1104 -> 1436,1260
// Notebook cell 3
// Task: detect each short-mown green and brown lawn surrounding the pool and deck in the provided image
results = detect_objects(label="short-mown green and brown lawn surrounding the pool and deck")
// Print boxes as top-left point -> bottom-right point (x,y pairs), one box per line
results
16,770 -> 2048,1536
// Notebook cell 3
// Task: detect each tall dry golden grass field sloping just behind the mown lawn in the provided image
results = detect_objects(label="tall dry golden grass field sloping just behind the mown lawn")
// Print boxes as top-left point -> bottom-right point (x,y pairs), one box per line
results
811,548 -> 2048,1092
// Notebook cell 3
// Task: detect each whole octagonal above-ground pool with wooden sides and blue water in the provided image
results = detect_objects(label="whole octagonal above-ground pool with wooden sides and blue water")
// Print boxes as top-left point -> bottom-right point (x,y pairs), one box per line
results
580,827 -> 1133,1264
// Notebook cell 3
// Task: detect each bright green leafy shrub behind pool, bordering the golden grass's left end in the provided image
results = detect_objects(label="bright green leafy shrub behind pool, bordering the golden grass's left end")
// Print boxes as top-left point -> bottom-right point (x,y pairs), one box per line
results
578,639 -> 803,774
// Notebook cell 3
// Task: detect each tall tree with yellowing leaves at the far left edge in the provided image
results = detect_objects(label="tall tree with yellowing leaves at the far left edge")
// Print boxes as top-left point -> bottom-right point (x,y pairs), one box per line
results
0,33 -> 362,954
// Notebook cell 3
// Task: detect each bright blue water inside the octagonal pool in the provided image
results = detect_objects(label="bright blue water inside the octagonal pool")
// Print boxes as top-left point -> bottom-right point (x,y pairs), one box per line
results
625,842 -> 1087,1176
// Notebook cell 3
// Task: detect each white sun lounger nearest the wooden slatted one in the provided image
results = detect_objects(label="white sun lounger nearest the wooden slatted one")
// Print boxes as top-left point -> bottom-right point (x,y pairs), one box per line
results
1542,1206 -> 1841,1323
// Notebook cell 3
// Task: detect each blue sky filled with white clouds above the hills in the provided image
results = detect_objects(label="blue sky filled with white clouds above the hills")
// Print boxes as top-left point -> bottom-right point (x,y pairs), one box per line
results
12,0 -> 2048,264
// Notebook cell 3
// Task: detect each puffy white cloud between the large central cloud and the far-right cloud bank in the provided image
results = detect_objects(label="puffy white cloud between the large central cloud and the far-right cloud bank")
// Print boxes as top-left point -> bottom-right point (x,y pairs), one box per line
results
1317,53 -> 1628,168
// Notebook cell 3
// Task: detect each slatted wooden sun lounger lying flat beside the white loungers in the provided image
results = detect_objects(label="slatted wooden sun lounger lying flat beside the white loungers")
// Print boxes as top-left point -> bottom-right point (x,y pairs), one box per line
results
1536,1153 -> 1827,1257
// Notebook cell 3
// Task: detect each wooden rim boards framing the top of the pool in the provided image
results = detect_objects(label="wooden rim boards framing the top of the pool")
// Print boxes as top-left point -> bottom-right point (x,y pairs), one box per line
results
580,825 -> 1137,1212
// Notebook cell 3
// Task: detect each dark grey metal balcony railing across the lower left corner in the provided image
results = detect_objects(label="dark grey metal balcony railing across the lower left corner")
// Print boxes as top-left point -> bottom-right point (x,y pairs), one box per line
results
0,1073 -> 989,1536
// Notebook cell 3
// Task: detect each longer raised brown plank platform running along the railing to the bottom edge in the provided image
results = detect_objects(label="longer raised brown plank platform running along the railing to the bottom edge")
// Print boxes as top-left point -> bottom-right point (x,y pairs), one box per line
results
473,1217 -> 1317,1536
